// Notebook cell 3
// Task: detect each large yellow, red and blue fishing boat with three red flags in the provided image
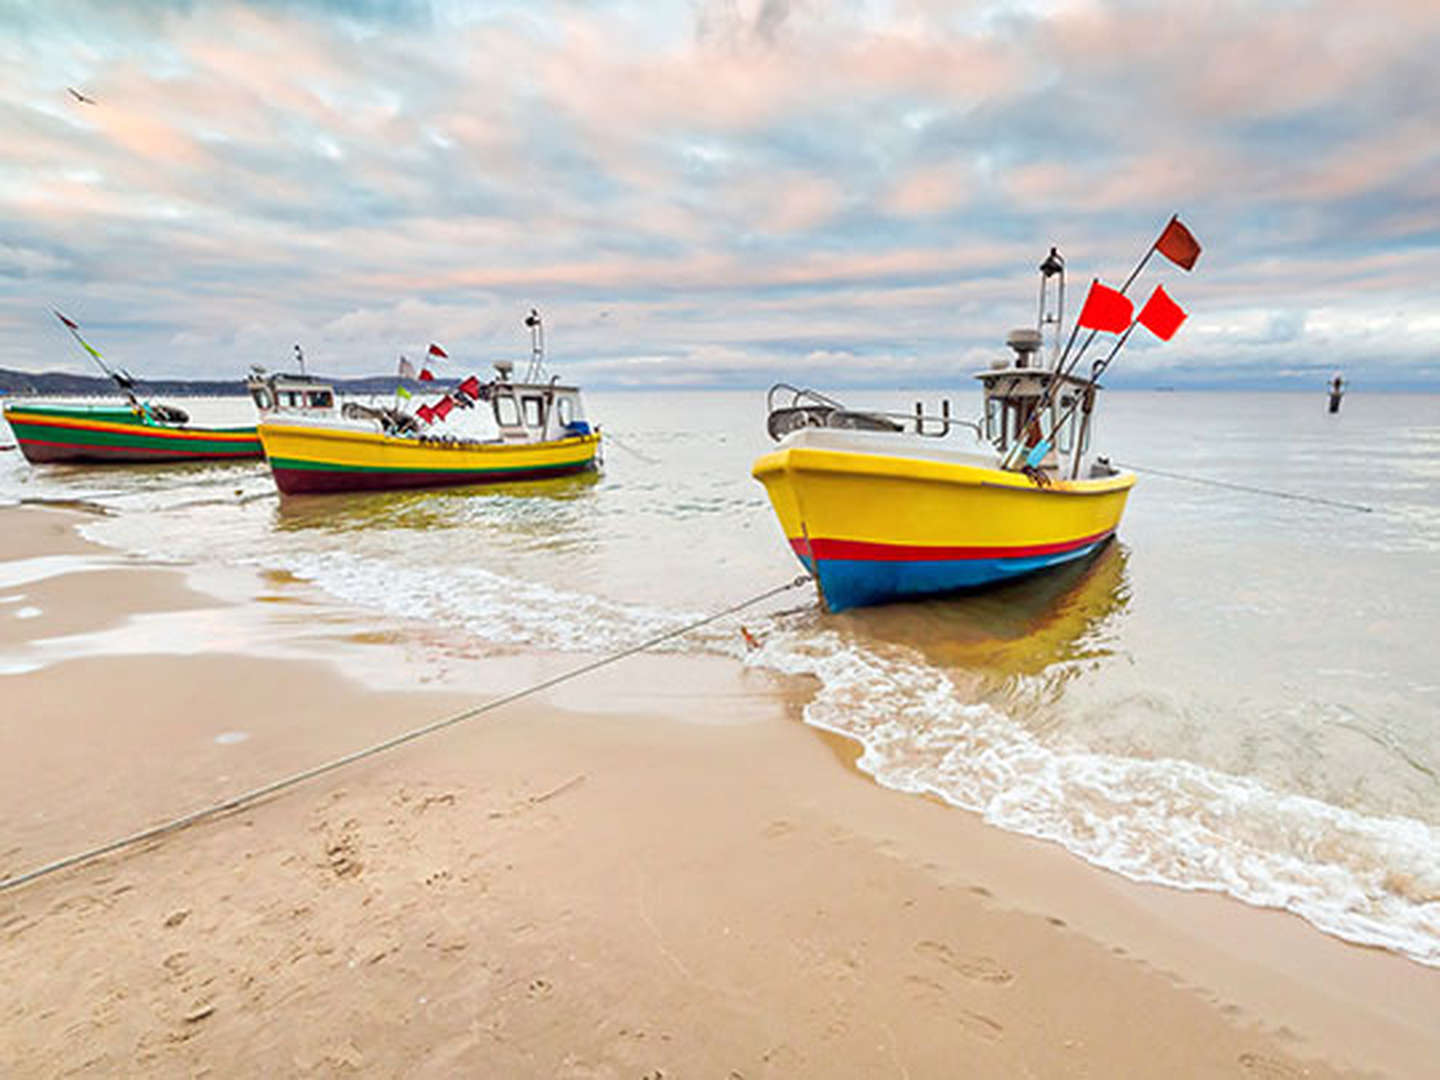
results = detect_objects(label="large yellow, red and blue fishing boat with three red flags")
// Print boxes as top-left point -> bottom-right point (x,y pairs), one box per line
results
753,219 -> 1200,612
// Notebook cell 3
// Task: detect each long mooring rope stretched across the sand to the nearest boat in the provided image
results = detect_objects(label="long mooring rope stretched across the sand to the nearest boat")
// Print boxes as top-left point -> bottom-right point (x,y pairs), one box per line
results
0,575 -> 811,893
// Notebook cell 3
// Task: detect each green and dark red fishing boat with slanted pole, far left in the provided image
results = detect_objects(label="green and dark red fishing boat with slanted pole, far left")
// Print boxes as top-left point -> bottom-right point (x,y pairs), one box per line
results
4,311 -> 262,465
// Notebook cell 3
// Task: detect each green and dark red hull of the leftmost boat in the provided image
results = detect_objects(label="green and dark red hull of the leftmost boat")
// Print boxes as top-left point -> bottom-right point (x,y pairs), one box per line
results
4,405 -> 262,465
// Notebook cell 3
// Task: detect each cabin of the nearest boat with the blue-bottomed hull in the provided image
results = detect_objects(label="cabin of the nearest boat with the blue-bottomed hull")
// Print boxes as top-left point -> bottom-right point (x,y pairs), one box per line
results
975,328 -> 1099,475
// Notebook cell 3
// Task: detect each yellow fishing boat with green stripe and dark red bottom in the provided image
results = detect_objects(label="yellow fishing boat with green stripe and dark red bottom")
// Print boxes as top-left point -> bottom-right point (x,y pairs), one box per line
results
251,311 -> 600,495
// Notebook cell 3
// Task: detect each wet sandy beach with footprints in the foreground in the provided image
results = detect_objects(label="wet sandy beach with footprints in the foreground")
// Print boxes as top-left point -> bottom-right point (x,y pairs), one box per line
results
0,508 -> 1440,1080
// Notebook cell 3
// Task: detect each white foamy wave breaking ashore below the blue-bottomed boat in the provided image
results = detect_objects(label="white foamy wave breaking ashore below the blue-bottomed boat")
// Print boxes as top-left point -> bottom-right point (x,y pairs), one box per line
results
752,631 -> 1440,966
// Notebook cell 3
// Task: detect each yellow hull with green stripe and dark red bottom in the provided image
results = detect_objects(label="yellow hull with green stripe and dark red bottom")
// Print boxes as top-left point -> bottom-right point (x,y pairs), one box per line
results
259,420 -> 600,495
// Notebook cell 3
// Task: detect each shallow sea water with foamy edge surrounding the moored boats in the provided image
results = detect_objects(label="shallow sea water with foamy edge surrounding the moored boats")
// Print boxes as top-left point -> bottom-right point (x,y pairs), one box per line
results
0,390 -> 1440,965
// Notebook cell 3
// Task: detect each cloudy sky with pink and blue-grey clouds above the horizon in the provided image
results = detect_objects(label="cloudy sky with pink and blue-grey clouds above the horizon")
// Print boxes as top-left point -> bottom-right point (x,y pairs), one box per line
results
0,0 -> 1440,389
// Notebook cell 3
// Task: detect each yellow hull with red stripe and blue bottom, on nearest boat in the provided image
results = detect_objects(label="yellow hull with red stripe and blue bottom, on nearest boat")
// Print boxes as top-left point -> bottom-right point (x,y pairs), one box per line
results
753,445 -> 1135,611
